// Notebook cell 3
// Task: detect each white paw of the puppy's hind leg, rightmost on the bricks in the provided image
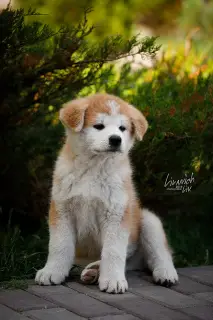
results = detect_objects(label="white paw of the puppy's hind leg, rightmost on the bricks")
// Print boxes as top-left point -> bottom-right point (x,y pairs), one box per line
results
153,264 -> 178,287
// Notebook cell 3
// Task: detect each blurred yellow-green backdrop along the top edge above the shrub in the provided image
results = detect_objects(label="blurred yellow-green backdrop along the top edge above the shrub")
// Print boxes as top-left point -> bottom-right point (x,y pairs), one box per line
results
14,0 -> 213,54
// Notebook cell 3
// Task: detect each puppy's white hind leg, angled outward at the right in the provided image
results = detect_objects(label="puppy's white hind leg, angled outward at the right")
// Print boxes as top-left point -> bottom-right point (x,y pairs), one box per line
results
141,209 -> 178,286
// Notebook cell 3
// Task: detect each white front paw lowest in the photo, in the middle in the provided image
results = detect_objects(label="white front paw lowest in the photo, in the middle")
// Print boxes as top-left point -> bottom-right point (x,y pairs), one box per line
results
98,277 -> 128,293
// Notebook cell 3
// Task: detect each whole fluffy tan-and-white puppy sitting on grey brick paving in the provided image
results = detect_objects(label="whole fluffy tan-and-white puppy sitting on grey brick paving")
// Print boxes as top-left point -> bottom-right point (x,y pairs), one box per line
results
36,94 -> 178,293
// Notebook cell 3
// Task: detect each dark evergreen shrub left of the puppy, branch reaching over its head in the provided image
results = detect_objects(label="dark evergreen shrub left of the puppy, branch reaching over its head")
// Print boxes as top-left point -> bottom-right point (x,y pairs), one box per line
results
0,4 -> 157,233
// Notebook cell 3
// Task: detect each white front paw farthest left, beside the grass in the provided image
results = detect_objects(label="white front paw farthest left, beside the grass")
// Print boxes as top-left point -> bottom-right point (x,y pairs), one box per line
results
35,267 -> 67,286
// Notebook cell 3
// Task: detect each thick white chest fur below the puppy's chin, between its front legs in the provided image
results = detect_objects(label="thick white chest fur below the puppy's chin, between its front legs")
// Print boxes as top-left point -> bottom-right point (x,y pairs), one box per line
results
52,153 -> 130,247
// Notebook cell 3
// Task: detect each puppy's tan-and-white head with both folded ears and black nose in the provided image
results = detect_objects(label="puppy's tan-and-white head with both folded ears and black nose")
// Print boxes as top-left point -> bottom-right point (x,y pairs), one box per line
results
60,94 -> 148,154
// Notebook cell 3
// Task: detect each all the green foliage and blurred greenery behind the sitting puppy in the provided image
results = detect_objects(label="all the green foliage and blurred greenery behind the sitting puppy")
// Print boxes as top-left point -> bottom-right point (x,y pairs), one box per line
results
0,0 -> 213,281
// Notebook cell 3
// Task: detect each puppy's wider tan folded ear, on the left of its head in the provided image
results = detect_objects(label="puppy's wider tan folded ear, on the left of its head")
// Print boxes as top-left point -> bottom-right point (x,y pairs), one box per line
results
59,98 -> 88,132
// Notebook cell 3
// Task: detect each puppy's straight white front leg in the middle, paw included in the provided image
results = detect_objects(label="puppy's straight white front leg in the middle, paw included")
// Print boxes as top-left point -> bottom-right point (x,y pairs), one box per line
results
99,221 -> 129,293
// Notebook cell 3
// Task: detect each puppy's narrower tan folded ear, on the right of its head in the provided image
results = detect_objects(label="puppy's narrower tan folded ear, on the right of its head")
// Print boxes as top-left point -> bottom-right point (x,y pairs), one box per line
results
129,105 -> 148,141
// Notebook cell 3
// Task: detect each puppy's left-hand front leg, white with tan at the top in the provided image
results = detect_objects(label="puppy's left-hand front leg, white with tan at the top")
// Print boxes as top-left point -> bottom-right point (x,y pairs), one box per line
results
35,202 -> 75,285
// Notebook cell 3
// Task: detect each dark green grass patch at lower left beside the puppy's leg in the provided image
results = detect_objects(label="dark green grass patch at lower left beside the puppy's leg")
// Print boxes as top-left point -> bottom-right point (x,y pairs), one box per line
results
0,221 -> 48,282
